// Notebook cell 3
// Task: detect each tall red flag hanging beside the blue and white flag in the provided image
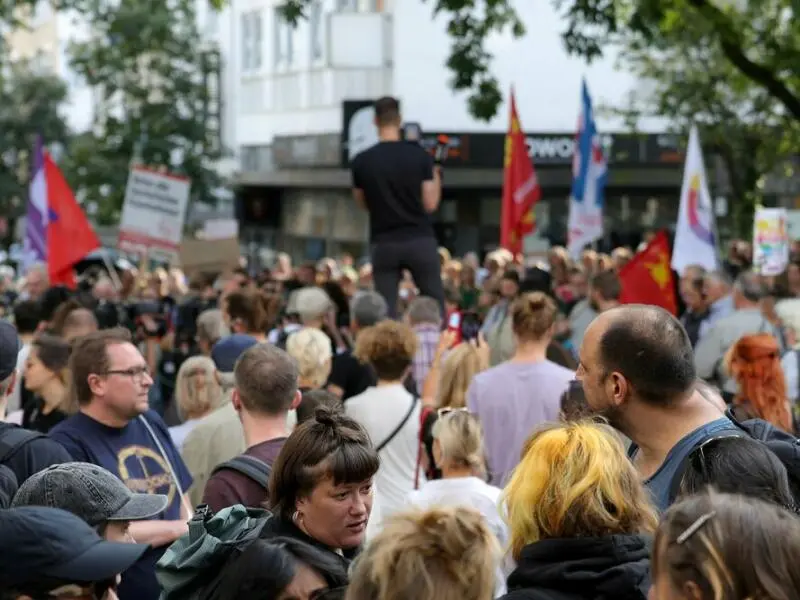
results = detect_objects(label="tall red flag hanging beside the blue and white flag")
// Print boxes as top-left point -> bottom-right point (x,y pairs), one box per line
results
500,89 -> 542,254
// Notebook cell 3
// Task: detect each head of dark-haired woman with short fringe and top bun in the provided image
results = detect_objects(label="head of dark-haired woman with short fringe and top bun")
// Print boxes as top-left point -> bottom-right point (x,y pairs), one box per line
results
262,408 -> 379,564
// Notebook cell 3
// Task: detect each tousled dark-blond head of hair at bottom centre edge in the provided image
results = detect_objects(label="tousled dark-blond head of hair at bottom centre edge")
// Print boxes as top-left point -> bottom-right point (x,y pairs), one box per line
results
345,507 -> 500,600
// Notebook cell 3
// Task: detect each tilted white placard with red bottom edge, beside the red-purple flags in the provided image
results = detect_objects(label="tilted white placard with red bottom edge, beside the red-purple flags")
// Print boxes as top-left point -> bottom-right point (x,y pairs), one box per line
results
119,167 -> 191,256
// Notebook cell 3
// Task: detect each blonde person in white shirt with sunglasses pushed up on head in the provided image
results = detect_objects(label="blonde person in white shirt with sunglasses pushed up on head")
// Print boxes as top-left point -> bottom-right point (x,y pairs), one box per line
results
408,408 -> 508,596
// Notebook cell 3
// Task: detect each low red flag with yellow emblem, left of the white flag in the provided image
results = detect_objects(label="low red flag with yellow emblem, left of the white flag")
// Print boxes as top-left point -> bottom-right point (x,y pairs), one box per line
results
619,231 -> 678,315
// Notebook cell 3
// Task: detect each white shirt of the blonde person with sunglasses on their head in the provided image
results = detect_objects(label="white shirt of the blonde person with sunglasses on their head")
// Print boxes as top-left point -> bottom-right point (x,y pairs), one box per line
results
408,477 -> 508,598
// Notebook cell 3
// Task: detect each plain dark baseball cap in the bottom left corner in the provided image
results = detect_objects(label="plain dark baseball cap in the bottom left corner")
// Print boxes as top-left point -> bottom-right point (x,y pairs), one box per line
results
0,506 -> 149,589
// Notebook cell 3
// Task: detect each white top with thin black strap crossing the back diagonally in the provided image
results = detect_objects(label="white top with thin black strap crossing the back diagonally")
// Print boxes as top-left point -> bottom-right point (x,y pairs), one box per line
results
344,384 -> 422,528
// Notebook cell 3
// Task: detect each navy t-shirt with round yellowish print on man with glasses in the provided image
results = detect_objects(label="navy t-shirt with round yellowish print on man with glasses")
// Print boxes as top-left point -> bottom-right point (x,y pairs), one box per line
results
50,410 -> 192,600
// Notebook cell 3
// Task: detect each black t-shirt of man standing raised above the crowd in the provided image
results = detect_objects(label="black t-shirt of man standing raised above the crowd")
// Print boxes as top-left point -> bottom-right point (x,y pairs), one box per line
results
351,141 -> 434,242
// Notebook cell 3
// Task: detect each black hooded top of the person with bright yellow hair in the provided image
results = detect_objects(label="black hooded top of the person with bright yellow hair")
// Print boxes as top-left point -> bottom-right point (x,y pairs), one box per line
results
502,535 -> 651,600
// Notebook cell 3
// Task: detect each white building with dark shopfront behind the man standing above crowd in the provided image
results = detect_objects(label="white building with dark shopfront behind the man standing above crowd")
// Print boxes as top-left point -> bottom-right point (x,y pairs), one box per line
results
228,0 -> 681,258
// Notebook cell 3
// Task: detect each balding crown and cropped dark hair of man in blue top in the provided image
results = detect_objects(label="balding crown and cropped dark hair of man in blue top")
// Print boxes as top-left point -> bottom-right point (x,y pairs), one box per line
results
597,304 -> 696,405
